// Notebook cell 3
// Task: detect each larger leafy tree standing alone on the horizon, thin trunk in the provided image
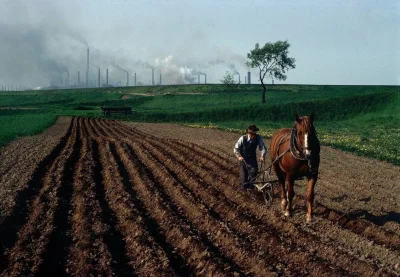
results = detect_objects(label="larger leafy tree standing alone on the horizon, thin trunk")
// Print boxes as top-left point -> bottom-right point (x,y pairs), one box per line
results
246,41 -> 296,103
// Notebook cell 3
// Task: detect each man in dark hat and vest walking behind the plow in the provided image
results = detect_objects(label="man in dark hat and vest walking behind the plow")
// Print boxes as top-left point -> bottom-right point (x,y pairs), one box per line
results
233,125 -> 267,190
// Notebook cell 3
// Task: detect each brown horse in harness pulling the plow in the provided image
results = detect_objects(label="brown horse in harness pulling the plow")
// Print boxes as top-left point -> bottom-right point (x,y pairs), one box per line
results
270,114 -> 320,222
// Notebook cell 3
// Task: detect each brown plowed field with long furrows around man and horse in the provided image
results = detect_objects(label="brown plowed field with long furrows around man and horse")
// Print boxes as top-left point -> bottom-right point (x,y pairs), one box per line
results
0,118 -> 400,276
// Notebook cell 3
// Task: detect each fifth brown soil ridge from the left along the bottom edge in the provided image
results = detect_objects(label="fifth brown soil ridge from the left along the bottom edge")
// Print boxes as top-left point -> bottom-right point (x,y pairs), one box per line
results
123,139 -> 308,275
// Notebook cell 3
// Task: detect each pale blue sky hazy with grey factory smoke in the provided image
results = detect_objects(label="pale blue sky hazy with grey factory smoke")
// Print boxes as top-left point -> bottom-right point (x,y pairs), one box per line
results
0,0 -> 400,89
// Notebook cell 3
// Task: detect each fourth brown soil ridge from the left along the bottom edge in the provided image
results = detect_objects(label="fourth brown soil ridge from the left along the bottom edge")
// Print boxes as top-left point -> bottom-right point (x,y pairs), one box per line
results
114,141 -> 250,276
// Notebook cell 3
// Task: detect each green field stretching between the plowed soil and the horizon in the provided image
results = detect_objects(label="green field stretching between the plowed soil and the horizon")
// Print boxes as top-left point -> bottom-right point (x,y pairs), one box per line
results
0,85 -> 400,165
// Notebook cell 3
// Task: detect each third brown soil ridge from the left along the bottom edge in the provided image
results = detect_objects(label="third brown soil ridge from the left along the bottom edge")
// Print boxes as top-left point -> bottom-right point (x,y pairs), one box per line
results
90,122 -> 176,276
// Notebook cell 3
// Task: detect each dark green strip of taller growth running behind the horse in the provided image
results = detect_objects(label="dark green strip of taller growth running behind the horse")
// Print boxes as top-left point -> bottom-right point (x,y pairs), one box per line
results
119,92 -> 396,123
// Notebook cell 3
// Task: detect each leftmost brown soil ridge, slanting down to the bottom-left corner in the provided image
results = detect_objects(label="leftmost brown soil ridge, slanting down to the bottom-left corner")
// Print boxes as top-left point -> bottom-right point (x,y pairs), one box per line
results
2,119 -> 77,276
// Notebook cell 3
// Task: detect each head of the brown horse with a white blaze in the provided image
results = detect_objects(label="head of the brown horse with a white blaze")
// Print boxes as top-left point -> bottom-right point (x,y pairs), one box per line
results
296,114 -> 319,159
